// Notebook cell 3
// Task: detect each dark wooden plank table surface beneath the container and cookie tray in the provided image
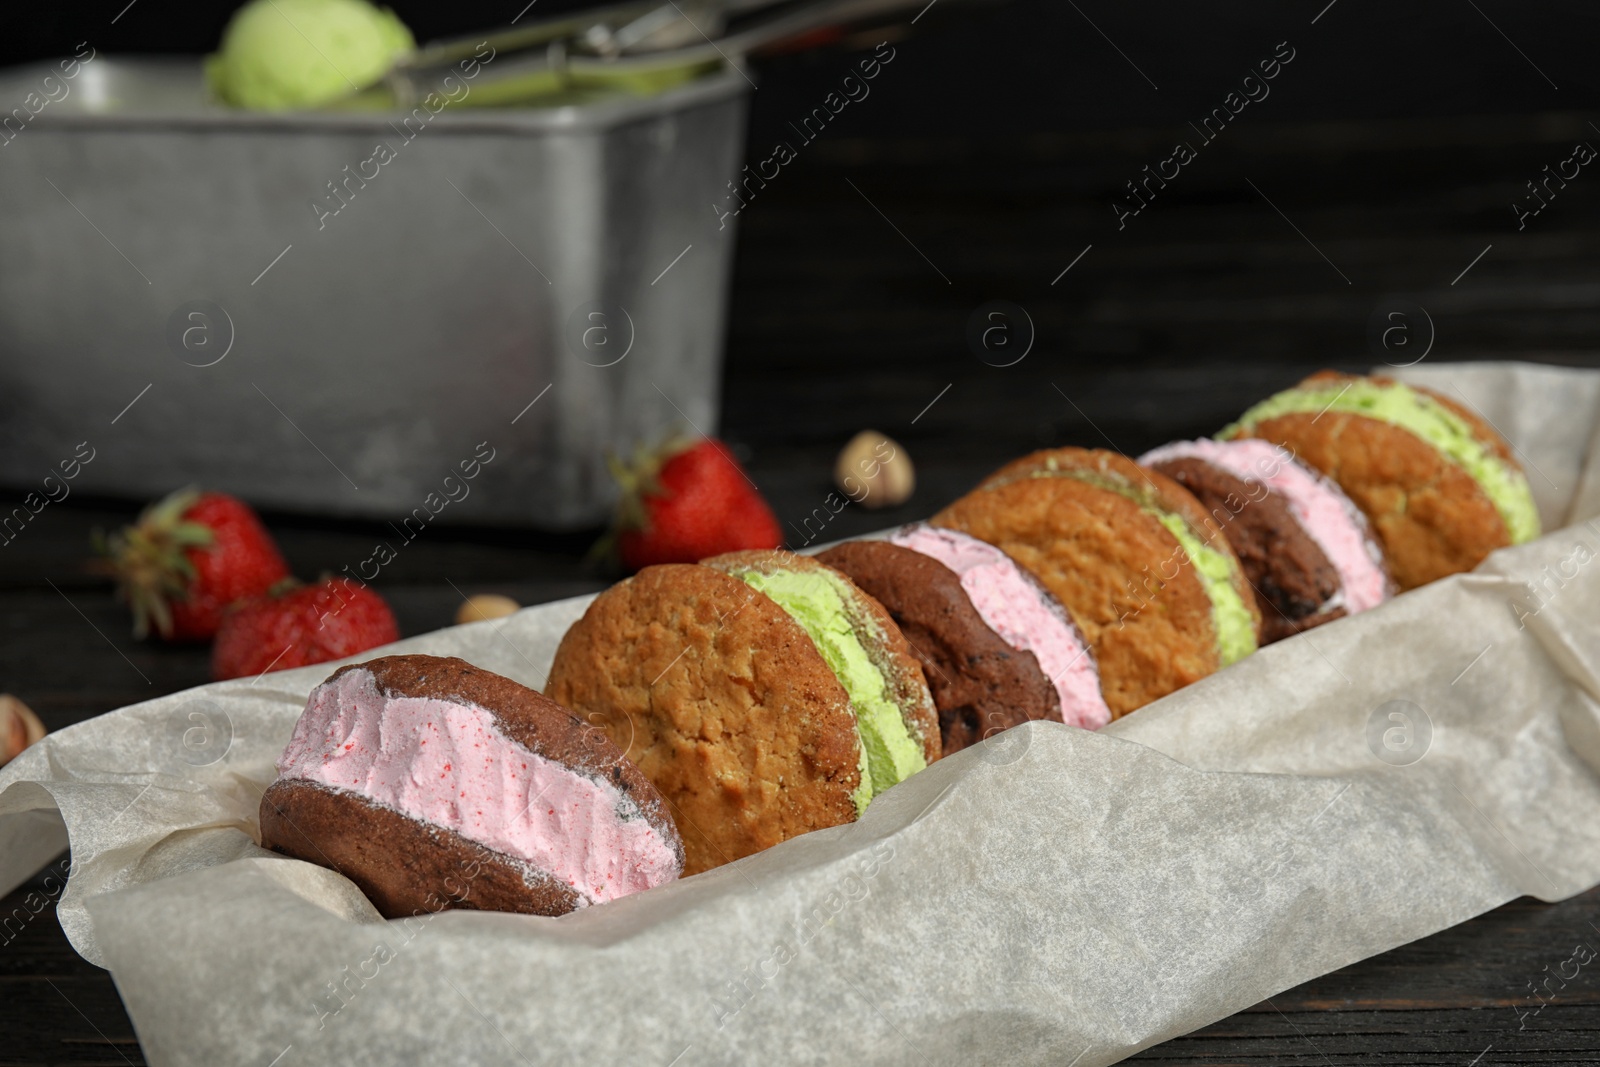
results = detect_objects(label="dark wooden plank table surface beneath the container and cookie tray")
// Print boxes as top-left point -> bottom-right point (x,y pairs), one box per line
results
0,97 -> 1600,1067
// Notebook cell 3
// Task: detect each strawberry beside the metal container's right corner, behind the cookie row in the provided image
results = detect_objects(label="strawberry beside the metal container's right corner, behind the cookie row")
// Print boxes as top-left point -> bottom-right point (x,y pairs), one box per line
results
611,438 -> 784,571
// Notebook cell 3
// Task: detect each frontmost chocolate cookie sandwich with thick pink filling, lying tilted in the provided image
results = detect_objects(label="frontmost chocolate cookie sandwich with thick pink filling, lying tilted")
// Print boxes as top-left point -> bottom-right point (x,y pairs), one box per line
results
261,656 -> 683,918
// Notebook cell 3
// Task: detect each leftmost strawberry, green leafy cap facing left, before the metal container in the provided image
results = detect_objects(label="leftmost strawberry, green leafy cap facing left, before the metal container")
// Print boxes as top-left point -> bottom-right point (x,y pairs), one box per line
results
98,488 -> 290,641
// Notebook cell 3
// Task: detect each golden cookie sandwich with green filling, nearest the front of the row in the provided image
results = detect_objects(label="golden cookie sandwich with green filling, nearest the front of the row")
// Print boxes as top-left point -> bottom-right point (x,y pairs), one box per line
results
546,552 -> 941,873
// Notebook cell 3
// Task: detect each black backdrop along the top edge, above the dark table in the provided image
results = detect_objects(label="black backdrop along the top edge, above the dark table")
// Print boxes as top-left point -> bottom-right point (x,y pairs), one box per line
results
0,0 -> 1600,128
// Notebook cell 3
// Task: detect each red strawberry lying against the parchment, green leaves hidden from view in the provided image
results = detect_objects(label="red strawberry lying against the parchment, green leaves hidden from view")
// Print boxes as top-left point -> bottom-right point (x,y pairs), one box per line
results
211,577 -> 400,681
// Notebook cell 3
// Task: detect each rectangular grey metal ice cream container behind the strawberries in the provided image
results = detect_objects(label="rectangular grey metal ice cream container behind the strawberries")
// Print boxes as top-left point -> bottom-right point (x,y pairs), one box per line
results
0,56 -> 749,528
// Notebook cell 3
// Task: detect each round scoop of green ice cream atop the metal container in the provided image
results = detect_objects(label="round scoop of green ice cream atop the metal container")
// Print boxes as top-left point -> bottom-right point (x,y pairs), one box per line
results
206,0 -> 416,110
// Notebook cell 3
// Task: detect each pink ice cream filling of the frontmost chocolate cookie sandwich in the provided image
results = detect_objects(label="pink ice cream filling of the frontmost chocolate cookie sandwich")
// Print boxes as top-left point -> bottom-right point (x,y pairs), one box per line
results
278,670 -> 680,904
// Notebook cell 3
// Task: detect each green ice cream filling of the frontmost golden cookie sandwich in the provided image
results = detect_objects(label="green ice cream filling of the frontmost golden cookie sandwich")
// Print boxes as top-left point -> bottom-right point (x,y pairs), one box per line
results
734,571 -> 928,814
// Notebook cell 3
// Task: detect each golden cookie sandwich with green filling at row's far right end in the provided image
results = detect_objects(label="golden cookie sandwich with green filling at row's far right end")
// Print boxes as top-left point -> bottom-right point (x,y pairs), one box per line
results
1219,371 -> 1539,589
